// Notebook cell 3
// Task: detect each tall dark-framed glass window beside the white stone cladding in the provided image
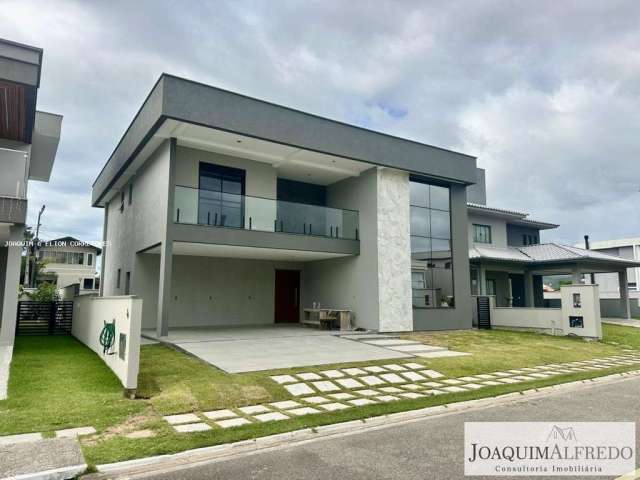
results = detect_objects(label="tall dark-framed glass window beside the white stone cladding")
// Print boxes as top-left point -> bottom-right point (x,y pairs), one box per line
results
410,178 -> 455,308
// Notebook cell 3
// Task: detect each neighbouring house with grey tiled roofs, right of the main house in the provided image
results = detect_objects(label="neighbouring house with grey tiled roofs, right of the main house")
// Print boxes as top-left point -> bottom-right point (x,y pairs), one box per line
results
468,175 -> 640,318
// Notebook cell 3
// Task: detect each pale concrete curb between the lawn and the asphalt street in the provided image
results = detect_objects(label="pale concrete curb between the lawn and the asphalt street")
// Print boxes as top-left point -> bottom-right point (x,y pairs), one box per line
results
90,370 -> 640,480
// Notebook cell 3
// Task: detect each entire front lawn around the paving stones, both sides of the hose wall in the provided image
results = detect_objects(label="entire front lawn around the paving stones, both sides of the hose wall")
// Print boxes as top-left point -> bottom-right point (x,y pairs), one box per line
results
0,325 -> 640,464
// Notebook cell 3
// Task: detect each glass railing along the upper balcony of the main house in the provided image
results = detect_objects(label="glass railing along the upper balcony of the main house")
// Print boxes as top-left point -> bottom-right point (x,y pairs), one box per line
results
173,186 -> 359,240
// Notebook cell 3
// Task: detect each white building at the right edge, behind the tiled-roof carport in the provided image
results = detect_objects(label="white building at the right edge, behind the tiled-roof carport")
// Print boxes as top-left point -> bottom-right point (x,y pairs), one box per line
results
577,237 -> 640,316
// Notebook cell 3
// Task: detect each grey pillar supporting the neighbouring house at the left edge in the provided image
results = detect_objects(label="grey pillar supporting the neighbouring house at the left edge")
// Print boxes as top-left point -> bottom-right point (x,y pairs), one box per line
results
0,225 -> 24,346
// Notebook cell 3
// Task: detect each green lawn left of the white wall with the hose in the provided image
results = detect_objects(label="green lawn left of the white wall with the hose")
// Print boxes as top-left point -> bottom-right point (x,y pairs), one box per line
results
0,337 -> 145,435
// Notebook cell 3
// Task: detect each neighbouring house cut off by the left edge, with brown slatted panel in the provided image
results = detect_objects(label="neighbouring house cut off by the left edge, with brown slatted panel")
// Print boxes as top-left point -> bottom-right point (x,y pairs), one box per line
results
0,39 -> 62,398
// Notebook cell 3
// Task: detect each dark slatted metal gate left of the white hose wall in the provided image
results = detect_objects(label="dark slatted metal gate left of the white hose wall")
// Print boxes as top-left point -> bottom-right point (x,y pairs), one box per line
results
16,300 -> 73,335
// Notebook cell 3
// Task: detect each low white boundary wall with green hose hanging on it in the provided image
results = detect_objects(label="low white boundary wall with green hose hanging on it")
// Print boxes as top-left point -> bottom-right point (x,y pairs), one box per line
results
71,295 -> 142,390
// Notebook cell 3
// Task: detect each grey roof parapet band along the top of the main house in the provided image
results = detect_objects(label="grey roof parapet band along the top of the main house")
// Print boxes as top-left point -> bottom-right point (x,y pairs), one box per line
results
93,74 -> 477,206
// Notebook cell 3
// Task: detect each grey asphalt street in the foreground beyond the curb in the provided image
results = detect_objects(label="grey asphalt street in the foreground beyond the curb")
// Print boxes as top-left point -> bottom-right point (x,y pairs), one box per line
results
126,378 -> 640,480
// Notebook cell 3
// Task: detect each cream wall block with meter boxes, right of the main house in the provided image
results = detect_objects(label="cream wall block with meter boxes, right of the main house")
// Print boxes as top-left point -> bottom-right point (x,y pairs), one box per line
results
560,284 -> 602,339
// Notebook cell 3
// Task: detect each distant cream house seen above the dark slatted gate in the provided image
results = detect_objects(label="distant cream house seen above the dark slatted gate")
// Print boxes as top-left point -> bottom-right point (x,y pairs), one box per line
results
36,237 -> 101,295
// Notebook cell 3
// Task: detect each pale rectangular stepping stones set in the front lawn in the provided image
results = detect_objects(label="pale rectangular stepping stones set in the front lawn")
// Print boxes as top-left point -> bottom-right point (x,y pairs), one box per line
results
151,354 -> 640,436
